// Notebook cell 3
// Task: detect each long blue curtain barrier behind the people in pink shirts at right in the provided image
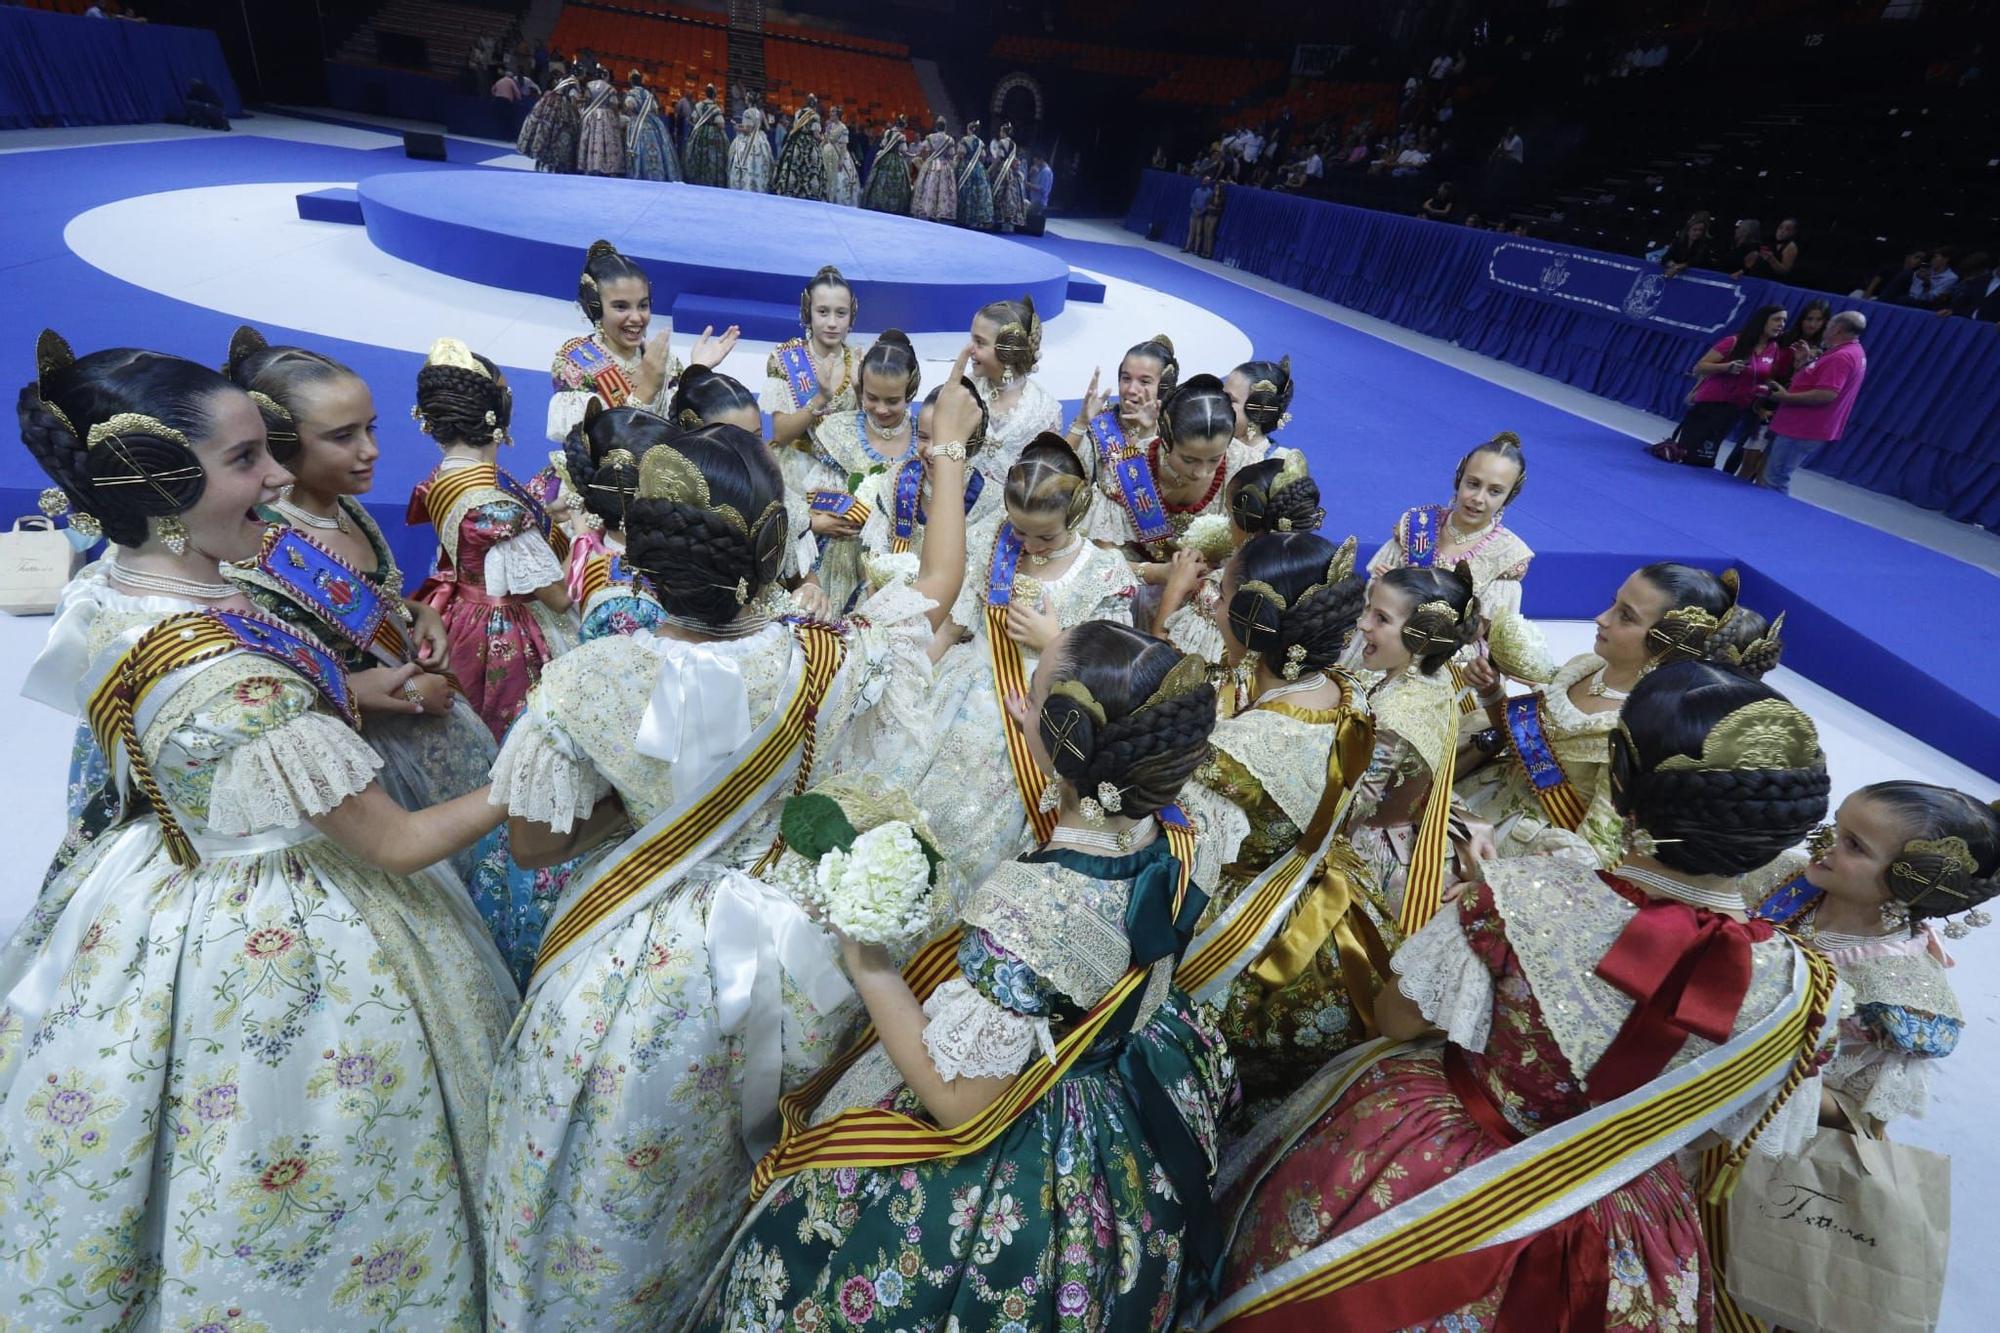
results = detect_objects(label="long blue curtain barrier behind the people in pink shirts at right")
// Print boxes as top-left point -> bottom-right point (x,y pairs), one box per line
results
1126,170 -> 2000,528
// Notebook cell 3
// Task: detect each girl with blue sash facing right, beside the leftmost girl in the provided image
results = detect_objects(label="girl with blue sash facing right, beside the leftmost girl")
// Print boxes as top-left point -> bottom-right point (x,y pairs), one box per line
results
226,326 -> 494,877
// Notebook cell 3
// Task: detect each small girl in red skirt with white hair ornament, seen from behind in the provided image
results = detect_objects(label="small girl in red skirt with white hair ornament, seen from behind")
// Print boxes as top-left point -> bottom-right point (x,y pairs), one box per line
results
398,338 -> 576,741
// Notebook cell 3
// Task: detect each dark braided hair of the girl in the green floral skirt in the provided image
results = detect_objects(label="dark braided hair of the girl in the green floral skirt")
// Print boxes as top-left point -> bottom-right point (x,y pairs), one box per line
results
1040,620 -> 1216,819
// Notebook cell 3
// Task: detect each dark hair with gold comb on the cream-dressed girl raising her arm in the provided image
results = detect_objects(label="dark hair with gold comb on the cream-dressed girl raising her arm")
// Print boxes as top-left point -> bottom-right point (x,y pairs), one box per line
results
624,422 -> 786,624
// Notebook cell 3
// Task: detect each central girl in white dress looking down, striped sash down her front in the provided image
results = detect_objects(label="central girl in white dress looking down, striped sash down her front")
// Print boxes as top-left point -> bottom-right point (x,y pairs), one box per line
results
888,436 -> 1132,885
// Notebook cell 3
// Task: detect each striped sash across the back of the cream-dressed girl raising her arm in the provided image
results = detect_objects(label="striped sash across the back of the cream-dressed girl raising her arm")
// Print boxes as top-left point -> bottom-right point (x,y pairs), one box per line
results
534,622 -> 846,973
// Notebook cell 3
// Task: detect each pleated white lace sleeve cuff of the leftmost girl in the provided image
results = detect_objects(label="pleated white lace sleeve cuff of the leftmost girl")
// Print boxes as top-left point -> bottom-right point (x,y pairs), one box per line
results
208,713 -> 382,837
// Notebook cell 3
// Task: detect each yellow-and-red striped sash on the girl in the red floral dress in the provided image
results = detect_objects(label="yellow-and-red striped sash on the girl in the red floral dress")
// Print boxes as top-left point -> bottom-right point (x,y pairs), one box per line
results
1206,949 -> 1836,1327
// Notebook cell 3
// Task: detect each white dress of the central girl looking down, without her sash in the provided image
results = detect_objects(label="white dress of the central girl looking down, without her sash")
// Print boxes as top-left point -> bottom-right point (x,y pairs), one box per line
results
886,520 -> 1132,885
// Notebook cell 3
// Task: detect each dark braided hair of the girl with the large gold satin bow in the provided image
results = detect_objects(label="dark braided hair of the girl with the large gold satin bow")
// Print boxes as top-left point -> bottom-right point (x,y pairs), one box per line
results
1224,532 -> 1368,679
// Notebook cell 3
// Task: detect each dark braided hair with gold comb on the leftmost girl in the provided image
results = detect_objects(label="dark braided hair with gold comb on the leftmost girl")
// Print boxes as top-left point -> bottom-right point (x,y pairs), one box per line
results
14,332 -> 240,546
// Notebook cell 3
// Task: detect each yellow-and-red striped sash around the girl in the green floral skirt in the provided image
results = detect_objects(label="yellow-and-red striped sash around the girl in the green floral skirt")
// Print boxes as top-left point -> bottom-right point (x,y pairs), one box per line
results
750,807 -> 1194,1199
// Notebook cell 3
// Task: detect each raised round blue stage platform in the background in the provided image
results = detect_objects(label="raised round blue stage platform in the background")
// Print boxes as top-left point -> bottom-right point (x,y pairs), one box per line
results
358,170 -> 1070,338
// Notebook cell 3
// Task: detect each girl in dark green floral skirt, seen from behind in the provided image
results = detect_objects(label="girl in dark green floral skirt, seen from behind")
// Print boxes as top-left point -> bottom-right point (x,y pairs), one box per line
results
706,616 -> 1236,1329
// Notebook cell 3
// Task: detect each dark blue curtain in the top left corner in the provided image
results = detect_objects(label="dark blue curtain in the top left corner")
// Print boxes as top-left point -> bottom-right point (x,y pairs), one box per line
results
0,8 -> 244,130
